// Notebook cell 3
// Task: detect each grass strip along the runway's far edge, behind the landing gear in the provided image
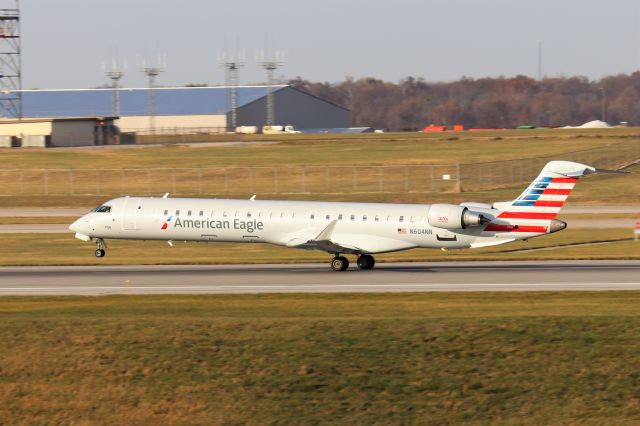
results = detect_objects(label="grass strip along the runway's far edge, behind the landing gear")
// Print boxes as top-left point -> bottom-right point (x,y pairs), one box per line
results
0,229 -> 640,266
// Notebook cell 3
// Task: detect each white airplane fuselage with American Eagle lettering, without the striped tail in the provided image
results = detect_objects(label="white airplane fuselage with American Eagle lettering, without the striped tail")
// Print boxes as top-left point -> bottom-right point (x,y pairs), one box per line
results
70,197 -> 541,253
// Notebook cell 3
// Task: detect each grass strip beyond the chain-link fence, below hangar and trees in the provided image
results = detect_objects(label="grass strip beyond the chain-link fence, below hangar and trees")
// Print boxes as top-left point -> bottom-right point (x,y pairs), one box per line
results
0,128 -> 640,170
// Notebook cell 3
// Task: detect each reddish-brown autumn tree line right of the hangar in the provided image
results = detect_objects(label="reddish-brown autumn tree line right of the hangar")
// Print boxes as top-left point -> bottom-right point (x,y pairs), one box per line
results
287,71 -> 640,130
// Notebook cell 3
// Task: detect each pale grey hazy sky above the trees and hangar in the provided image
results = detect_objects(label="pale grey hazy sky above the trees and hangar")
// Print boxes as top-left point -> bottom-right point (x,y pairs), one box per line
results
12,0 -> 640,89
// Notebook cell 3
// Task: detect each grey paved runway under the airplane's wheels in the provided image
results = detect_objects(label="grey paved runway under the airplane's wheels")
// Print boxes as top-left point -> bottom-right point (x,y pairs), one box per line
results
0,261 -> 640,295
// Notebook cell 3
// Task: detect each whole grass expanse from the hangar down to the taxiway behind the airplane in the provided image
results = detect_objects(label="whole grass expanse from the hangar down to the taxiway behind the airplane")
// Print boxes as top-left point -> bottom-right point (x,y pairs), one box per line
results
0,129 -> 640,207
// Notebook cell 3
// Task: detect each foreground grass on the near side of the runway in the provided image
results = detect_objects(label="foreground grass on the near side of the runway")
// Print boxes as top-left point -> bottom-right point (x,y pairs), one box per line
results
0,292 -> 640,425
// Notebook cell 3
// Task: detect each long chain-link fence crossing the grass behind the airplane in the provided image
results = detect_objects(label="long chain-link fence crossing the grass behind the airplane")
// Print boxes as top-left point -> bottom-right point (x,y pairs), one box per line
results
0,141 -> 640,196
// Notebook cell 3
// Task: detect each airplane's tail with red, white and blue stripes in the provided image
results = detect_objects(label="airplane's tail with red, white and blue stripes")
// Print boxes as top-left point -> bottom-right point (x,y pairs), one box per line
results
484,161 -> 596,239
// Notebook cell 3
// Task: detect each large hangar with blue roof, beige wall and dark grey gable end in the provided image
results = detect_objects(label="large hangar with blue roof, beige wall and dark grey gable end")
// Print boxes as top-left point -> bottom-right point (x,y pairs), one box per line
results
22,85 -> 351,133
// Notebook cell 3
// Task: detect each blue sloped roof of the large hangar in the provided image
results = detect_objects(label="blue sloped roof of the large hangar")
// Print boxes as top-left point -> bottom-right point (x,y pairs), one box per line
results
22,85 -> 288,117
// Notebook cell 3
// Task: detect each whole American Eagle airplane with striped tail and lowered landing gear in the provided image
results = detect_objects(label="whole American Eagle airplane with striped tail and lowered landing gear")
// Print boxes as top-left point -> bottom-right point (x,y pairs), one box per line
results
69,161 -> 609,271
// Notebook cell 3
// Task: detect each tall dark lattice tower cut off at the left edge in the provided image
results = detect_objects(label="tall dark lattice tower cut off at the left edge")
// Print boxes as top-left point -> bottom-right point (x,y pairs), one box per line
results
0,0 -> 22,119
